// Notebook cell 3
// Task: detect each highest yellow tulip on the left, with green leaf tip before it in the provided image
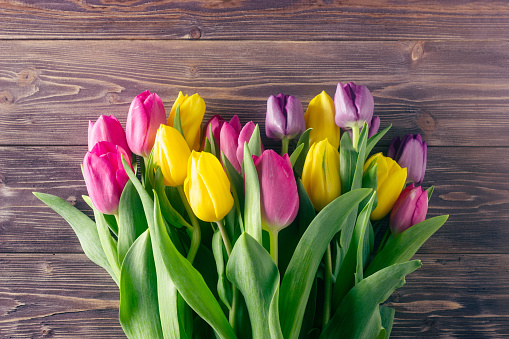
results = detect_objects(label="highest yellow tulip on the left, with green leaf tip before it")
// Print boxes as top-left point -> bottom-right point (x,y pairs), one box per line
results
168,92 -> 205,151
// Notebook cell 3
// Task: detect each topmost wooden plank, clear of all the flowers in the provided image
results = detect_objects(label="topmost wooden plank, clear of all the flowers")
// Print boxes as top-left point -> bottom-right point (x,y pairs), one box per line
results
0,0 -> 509,40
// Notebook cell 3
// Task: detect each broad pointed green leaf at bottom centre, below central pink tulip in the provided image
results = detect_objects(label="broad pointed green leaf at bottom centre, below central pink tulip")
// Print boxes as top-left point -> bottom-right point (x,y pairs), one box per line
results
226,233 -> 283,339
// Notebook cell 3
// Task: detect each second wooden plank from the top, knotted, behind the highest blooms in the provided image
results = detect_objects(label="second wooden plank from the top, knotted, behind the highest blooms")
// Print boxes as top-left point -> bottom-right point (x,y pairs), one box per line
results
0,41 -> 509,146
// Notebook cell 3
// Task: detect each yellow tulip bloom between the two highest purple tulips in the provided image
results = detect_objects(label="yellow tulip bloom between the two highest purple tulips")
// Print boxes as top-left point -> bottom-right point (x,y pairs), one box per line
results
304,91 -> 341,149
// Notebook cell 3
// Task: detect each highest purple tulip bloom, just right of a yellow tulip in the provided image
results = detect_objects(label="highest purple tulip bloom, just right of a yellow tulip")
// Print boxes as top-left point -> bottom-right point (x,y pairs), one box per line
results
334,82 -> 375,129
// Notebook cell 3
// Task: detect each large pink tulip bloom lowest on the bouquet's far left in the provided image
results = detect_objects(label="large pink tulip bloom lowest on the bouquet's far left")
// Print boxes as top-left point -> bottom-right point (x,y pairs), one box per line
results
83,141 -> 131,214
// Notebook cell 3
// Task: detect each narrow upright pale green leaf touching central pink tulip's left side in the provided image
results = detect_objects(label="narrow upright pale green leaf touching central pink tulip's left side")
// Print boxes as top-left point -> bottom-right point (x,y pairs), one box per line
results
243,145 -> 262,244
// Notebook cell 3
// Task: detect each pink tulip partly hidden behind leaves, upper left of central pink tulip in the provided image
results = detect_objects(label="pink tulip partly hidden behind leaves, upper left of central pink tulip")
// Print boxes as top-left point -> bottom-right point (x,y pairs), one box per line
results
219,116 -> 264,173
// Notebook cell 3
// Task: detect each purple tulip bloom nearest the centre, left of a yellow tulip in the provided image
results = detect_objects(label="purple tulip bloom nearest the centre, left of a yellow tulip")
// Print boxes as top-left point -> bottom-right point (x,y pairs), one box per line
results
265,93 -> 306,140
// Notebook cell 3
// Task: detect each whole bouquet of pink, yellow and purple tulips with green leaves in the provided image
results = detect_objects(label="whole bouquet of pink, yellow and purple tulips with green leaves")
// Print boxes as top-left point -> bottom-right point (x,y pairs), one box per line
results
35,83 -> 447,339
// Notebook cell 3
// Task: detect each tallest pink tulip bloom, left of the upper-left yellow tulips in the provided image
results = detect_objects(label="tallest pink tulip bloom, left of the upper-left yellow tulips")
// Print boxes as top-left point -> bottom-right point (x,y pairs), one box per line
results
126,91 -> 166,158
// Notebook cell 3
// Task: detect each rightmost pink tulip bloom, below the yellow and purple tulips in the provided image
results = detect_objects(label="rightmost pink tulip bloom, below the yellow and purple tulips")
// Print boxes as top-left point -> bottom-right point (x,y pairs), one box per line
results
389,184 -> 428,236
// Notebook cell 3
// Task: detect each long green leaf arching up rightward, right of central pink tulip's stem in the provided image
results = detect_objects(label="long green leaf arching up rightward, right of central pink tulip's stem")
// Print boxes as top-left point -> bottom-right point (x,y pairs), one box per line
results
280,189 -> 371,338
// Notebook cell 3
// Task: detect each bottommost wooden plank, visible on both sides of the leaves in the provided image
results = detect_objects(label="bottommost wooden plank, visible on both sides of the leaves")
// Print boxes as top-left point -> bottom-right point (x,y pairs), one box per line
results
0,253 -> 509,339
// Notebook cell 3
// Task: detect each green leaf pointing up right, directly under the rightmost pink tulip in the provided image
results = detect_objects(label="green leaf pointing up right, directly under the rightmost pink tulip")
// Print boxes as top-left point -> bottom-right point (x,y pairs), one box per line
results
365,215 -> 449,276
